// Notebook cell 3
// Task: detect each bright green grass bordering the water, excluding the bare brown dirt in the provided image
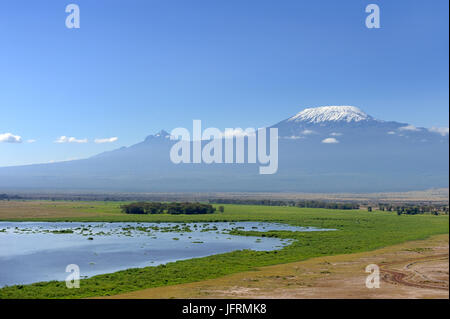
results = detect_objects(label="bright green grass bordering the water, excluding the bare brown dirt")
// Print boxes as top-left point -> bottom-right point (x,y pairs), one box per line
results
0,202 -> 449,298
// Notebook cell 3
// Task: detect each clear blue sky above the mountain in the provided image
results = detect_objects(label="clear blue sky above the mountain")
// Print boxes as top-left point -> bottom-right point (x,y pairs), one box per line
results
0,0 -> 449,166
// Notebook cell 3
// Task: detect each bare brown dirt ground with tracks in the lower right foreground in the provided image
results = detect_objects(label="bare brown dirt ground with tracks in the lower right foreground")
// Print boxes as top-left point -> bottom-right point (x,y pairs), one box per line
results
104,235 -> 449,299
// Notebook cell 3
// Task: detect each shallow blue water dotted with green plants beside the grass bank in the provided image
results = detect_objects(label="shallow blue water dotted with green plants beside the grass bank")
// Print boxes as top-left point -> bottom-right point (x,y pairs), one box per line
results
0,222 -> 330,287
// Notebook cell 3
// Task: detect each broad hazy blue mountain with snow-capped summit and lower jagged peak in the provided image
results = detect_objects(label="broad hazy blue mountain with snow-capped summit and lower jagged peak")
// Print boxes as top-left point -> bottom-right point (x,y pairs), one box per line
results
0,106 -> 449,192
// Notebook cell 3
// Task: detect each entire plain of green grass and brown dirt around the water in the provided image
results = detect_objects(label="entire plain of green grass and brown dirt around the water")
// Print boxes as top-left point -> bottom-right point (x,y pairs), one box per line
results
0,200 -> 449,298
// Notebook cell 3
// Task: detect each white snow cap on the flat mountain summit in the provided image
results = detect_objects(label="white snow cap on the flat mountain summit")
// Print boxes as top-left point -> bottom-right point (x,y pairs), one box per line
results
288,105 -> 373,123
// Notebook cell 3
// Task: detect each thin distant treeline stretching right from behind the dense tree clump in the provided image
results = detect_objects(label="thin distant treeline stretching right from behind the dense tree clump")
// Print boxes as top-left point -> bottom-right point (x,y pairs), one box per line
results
214,199 -> 359,209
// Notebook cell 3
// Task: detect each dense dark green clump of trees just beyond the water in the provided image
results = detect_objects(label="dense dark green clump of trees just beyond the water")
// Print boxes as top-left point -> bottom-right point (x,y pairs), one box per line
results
120,202 -> 218,215
